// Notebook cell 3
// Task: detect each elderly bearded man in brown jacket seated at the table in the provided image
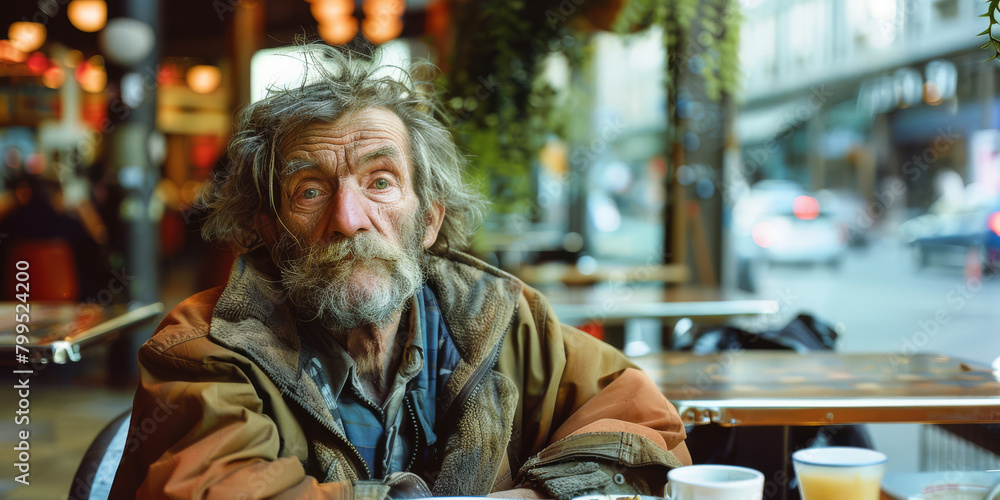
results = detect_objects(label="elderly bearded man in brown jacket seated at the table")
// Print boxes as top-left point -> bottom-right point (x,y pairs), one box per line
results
112,45 -> 690,499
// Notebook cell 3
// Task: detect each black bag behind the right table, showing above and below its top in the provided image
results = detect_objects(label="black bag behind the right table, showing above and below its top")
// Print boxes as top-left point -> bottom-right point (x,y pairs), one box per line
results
680,314 -> 873,498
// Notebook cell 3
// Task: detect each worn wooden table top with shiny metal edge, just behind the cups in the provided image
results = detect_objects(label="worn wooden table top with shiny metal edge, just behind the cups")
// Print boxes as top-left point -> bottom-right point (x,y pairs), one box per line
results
633,350 -> 1000,426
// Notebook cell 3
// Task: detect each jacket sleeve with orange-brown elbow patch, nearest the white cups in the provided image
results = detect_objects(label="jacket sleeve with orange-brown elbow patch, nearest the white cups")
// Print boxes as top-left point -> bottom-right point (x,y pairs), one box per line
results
499,288 -> 690,498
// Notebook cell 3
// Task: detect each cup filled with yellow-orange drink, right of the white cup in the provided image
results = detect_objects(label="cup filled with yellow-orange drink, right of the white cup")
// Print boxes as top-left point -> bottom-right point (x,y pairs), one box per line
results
792,446 -> 886,500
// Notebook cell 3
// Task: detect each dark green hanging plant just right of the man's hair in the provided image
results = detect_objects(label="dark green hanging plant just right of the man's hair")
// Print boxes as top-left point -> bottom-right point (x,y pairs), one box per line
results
440,0 -> 586,213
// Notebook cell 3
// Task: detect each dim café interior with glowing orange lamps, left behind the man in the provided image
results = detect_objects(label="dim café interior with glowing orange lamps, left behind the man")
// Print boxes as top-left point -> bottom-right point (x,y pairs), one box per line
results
0,0 -> 427,303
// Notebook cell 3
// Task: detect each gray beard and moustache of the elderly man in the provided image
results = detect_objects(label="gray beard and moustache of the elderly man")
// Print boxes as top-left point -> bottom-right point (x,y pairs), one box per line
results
276,217 -> 424,337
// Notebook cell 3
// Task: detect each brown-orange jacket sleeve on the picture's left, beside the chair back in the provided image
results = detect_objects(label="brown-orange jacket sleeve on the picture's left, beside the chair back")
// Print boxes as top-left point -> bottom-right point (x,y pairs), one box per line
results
111,296 -> 352,499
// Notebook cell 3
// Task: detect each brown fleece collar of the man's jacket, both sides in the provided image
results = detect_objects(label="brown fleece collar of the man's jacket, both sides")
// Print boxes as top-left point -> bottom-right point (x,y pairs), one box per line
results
209,248 -> 522,420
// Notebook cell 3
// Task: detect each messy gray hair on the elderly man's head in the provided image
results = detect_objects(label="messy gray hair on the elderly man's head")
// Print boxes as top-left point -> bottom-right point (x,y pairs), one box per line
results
201,44 -> 486,253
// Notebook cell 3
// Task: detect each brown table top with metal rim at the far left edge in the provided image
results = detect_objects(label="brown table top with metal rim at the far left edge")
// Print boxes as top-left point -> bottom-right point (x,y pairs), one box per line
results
0,302 -> 163,364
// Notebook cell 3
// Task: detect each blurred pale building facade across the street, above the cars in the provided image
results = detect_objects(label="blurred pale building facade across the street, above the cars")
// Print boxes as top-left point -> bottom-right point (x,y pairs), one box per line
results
726,0 -> 998,286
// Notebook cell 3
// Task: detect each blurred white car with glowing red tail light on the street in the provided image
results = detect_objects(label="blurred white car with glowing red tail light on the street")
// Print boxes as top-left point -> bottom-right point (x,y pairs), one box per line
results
733,180 -> 848,267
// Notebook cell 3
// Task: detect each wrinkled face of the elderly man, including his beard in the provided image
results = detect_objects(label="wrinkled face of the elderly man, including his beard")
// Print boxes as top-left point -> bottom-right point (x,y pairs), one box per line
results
275,108 -> 438,331
